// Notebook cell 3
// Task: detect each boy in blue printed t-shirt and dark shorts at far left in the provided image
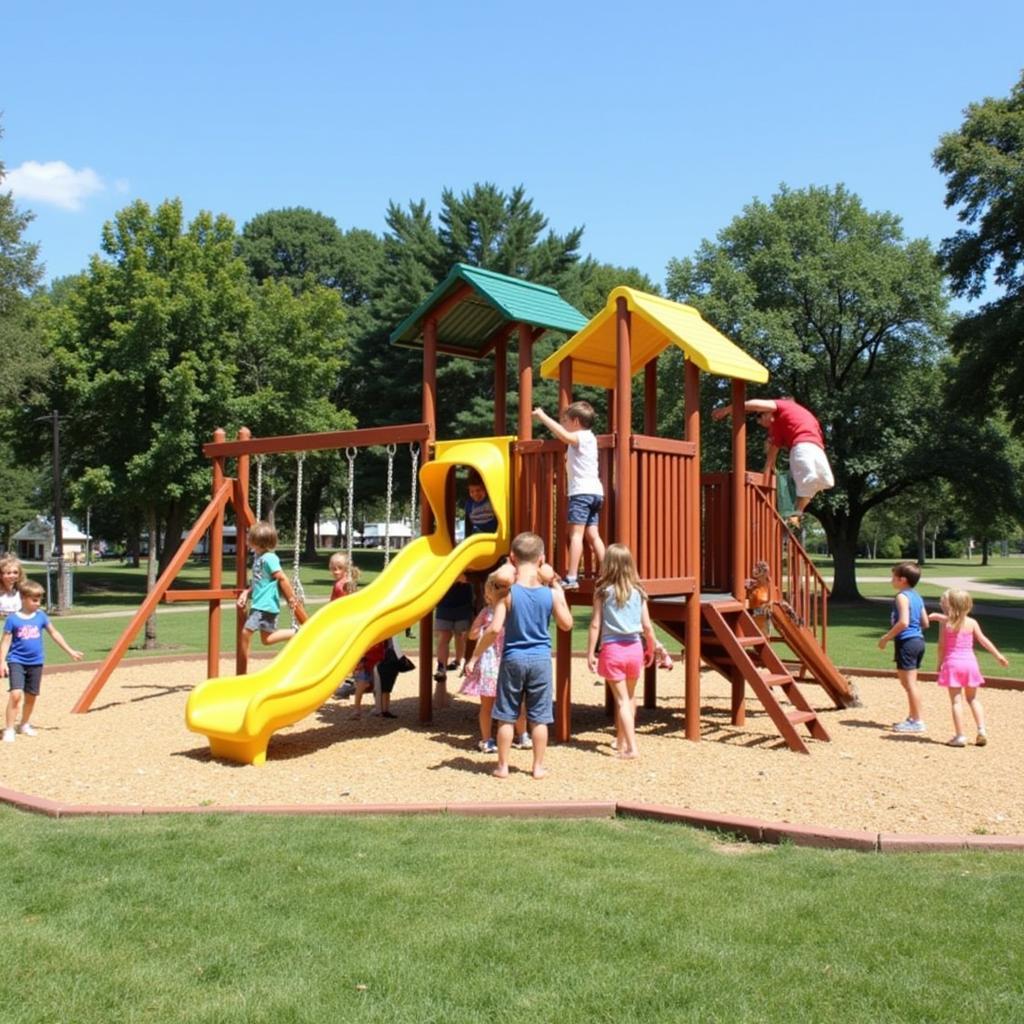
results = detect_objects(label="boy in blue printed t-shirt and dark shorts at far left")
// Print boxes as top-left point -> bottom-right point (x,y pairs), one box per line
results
0,580 -> 83,743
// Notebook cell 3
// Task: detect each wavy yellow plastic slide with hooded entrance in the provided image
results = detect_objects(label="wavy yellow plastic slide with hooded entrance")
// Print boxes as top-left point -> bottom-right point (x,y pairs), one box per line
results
185,437 -> 513,765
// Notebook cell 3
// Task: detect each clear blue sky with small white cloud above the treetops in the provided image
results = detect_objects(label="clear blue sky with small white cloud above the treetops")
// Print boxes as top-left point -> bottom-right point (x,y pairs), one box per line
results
0,0 -> 1024,299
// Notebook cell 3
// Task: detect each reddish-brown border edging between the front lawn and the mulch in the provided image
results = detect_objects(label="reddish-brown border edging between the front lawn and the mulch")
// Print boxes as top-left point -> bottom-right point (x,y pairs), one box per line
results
0,786 -> 1024,853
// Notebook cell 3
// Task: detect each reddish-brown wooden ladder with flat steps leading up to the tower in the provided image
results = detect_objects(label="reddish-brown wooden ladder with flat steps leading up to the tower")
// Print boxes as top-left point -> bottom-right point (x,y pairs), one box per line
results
700,601 -> 829,754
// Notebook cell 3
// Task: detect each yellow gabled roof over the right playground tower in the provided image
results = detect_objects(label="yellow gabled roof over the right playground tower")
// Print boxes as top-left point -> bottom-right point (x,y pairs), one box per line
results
541,287 -> 768,388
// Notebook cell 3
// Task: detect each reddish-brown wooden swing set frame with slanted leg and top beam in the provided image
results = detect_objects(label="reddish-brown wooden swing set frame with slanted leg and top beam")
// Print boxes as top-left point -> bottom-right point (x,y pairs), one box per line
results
72,423 -> 433,715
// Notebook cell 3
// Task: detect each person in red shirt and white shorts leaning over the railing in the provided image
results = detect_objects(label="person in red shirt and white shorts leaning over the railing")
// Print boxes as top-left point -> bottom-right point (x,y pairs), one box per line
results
711,398 -> 836,526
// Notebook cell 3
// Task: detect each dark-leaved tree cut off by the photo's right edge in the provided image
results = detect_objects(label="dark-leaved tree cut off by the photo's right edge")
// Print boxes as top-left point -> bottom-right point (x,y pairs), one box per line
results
934,73 -> 1024,432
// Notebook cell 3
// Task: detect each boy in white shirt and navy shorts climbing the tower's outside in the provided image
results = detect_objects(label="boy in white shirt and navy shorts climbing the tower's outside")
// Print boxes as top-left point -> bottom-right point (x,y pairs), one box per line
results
534,401 -> 604,590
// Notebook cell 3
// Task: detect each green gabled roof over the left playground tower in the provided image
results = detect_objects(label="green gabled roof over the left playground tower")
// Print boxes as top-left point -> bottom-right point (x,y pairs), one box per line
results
391,263 -> 587,359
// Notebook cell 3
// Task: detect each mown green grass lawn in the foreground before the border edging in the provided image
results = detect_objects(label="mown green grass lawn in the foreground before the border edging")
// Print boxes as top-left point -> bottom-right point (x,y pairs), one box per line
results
0,808 -> 1024,1024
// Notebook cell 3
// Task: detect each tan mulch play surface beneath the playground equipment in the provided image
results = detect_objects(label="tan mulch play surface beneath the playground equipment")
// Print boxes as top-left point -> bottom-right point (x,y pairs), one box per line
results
0,659 -> 1024,836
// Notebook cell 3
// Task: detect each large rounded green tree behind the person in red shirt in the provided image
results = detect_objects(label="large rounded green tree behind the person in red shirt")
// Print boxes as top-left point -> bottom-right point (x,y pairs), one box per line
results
668,185 -> 946,600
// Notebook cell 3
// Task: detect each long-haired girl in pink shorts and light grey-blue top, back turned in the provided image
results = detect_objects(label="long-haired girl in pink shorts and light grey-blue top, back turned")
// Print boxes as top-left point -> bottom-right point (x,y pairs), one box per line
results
587,544 -> 654,759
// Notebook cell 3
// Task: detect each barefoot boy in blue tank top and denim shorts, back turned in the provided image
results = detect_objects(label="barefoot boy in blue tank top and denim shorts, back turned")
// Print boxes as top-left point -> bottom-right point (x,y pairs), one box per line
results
466,534 -> 572,778
